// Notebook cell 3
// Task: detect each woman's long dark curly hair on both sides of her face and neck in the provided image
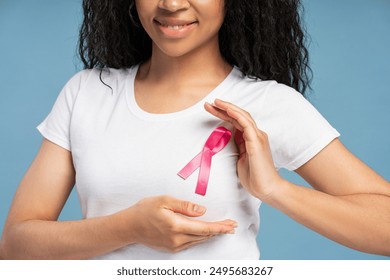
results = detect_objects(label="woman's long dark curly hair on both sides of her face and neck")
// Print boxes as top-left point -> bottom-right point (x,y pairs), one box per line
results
78,0 -> 312,94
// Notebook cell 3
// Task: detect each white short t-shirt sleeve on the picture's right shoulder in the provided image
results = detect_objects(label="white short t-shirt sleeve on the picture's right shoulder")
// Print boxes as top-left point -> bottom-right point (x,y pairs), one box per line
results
259,83 -> 340,170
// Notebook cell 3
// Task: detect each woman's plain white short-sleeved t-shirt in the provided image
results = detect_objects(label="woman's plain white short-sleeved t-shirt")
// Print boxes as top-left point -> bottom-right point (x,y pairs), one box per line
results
38,66 -> 339,259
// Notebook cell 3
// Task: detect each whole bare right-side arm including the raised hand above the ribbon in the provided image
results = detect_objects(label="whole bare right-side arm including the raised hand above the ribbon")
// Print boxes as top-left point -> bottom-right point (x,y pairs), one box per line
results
209,100 -> 390,255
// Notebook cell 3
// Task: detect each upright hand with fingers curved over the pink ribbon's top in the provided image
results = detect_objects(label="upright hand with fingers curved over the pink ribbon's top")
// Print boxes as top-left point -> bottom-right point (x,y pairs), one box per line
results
205,99 -> 284,201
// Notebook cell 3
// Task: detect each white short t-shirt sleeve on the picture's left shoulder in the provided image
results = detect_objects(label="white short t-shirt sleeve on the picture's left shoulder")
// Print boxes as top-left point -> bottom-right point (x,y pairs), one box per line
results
37,71 -> 83,151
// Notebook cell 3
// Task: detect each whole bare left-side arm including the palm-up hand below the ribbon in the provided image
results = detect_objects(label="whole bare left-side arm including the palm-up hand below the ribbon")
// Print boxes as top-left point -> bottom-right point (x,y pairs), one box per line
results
0,140 -> 236,259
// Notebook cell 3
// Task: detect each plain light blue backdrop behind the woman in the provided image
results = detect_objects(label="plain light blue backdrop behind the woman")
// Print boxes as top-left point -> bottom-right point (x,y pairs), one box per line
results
0,0 -> 390,259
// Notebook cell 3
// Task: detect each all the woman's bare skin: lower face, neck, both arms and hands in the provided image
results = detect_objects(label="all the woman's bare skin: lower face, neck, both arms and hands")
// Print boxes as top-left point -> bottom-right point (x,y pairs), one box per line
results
0,0 -> 390,259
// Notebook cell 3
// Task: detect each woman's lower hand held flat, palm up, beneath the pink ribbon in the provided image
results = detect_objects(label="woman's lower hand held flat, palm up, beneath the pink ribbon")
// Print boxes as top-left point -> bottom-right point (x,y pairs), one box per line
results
118,196 -> 237,252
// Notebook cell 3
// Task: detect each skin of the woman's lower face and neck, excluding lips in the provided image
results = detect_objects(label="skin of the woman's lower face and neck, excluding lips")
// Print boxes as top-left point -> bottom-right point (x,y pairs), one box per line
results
134,0 -> 232,114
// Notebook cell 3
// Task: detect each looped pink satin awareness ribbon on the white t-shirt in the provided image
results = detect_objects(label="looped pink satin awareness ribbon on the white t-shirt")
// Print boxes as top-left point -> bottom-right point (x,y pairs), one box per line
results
177,126 -> 232,195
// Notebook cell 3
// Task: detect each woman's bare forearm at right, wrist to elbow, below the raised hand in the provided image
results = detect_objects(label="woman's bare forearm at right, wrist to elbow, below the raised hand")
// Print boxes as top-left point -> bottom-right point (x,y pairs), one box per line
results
264,182 -> 390,255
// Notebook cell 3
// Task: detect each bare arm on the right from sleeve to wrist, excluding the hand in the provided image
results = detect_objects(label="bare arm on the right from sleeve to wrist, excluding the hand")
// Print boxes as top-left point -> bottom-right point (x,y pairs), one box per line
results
272,139 -> 390,256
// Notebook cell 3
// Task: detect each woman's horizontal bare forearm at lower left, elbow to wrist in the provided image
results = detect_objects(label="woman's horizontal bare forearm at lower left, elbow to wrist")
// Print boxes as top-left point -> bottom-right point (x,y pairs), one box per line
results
2,212 -> 131,259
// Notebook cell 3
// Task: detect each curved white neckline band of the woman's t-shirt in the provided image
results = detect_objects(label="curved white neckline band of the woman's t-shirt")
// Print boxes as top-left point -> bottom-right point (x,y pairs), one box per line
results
126,65 -> 239,121
